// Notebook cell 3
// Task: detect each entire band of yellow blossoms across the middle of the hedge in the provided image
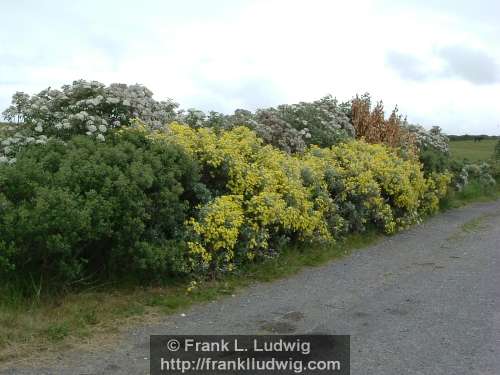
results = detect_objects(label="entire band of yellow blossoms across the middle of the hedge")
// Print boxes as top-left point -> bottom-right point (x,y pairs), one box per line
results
151,123 -> 450,269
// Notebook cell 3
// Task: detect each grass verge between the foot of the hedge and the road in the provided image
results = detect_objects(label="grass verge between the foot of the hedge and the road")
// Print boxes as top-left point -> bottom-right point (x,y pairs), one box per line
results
0,232 -> 381,367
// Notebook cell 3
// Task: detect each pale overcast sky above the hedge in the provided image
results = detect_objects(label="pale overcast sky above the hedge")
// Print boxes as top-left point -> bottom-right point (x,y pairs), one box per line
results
0,0 -> 500,134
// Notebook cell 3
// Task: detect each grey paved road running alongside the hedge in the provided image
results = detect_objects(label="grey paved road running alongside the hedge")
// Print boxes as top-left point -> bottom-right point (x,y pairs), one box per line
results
0,202 -> 500,375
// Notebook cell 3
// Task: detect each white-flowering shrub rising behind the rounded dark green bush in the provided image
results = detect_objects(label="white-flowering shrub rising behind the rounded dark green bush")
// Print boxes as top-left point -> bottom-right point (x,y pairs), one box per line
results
0,80 -> 178,162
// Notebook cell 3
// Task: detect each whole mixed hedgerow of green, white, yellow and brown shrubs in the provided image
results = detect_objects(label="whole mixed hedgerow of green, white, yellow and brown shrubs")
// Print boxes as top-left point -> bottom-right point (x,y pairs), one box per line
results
0,81 -> 458,287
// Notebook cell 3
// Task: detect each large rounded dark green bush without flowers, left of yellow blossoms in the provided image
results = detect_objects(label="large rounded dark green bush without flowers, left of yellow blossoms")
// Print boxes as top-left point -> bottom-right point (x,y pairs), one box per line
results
0,132 -> 203,286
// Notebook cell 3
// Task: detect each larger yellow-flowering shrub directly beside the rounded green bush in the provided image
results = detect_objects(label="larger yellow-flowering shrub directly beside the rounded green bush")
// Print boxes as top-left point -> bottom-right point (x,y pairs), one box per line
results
157,123 -> 331,268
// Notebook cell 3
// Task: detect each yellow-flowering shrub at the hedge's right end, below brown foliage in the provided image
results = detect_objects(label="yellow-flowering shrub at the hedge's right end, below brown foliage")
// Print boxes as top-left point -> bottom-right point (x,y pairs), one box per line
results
305,141 -> 449,233
